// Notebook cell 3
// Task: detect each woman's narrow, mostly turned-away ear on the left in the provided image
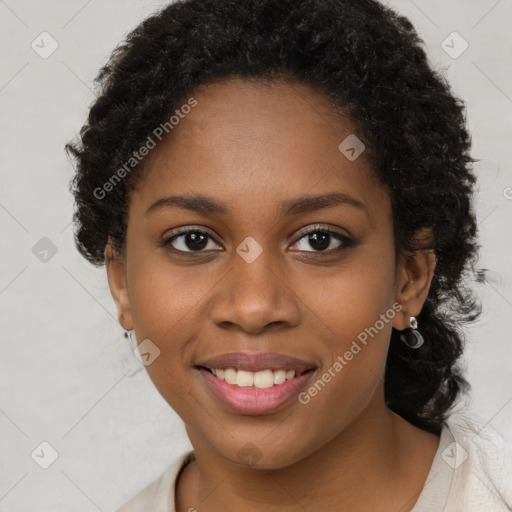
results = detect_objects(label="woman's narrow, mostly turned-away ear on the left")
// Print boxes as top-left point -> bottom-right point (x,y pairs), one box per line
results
105,237 -> 133,330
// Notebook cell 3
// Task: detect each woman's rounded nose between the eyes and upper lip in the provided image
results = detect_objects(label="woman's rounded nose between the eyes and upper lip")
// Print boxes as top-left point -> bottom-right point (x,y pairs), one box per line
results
209,250 -> 301,334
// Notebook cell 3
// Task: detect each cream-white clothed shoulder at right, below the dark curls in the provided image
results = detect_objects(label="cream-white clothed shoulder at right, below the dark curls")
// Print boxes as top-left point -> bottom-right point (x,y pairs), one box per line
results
441,413 -> 512,512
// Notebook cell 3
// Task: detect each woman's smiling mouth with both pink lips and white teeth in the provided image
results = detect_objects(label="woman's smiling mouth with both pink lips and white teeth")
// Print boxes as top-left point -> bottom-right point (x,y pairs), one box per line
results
194,352 -> 318,415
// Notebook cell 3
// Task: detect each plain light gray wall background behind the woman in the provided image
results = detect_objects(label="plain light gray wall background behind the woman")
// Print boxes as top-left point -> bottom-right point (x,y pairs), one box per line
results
0,0 -> 512,512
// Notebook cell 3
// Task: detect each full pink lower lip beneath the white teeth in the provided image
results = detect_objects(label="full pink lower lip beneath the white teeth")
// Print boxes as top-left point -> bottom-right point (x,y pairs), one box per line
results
199,368 -> 315,414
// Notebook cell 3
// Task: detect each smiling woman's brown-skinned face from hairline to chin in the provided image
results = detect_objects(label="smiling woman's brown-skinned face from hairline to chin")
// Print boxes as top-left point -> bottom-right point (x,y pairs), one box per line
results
107,75 -> 429,468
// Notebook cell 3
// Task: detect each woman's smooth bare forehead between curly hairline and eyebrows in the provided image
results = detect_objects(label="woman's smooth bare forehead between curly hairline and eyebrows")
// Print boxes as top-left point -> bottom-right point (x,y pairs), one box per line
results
130,78 -> 388,222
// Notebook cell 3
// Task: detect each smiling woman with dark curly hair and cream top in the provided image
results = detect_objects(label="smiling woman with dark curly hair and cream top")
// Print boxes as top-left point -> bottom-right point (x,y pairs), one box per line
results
67,0 -> 512,512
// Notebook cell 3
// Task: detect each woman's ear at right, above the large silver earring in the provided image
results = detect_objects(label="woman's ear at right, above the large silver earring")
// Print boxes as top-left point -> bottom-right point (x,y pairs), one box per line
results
393,228 -> 436,330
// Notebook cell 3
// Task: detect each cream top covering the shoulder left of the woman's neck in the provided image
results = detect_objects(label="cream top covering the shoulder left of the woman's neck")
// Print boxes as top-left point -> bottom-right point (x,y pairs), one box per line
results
116,450 -> 194,512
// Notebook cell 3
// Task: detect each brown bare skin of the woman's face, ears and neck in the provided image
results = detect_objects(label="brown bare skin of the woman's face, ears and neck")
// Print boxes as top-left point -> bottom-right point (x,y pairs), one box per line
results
105,78 -> 439,512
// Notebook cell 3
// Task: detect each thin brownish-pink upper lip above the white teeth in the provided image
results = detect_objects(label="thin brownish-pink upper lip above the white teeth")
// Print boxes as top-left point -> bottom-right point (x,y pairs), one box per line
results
196,352 -> 316,373
